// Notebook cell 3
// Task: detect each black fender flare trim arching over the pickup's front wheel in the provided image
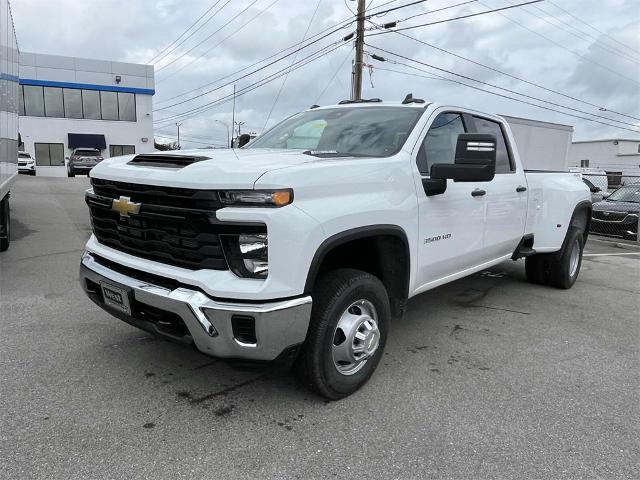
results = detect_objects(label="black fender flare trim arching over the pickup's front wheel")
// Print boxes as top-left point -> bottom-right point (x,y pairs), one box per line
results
304,224 -> 411,297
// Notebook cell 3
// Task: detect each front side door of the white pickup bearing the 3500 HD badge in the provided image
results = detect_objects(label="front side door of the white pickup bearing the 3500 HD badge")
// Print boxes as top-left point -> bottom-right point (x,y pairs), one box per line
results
414,110 -> 486,291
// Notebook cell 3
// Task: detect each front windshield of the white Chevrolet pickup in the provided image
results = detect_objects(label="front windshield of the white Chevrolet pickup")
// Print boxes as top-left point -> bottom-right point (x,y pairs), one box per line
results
246,107 -> 424,157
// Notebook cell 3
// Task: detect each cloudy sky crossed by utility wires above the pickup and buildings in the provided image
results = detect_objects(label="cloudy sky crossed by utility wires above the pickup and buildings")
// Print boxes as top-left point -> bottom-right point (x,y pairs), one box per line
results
12,0 -> 640,147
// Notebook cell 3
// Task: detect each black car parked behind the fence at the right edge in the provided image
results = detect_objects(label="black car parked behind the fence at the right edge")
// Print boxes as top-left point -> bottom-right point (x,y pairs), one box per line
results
591,183 -> 640,240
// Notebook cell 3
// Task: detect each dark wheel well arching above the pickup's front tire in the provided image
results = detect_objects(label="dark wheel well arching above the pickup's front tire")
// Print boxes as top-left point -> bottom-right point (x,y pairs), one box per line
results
305,232 -> 410,318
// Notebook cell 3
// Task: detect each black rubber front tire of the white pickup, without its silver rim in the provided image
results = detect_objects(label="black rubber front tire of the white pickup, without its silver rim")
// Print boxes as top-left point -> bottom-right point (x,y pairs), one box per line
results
294,269 -> 391,400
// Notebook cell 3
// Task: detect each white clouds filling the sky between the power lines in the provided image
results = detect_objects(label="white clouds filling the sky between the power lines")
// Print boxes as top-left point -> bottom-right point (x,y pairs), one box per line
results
13,0 -> 640,146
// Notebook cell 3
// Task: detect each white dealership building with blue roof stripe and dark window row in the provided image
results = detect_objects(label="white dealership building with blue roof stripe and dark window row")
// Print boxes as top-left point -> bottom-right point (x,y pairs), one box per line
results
18,52 -> 155,176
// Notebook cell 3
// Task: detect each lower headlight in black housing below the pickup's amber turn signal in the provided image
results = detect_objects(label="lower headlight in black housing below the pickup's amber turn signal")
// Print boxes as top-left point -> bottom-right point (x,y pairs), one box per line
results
221,233 -> 269,278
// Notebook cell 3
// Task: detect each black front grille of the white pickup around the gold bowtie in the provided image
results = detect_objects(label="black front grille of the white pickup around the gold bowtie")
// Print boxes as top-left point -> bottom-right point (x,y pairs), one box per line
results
87,179 -> 266,270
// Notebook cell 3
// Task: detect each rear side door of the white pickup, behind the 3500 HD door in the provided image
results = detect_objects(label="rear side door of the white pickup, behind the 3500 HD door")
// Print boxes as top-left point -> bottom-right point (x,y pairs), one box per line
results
469,115 -> 527,259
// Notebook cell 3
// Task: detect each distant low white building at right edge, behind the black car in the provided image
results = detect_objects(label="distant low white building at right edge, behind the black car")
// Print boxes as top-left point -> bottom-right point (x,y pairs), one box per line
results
569,138 -> 640,188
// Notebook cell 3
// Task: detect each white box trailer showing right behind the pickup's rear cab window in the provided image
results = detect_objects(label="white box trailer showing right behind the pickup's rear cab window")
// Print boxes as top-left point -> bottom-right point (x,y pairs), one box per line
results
502,115 -> 573,171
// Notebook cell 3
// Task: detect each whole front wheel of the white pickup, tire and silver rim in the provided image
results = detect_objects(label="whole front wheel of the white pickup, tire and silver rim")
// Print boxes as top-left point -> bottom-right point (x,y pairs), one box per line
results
294,269 -> 391,400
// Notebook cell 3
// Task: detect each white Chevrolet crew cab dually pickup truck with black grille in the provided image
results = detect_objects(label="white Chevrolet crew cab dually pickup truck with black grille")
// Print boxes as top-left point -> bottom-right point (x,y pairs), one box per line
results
80,97 -> 591,399
